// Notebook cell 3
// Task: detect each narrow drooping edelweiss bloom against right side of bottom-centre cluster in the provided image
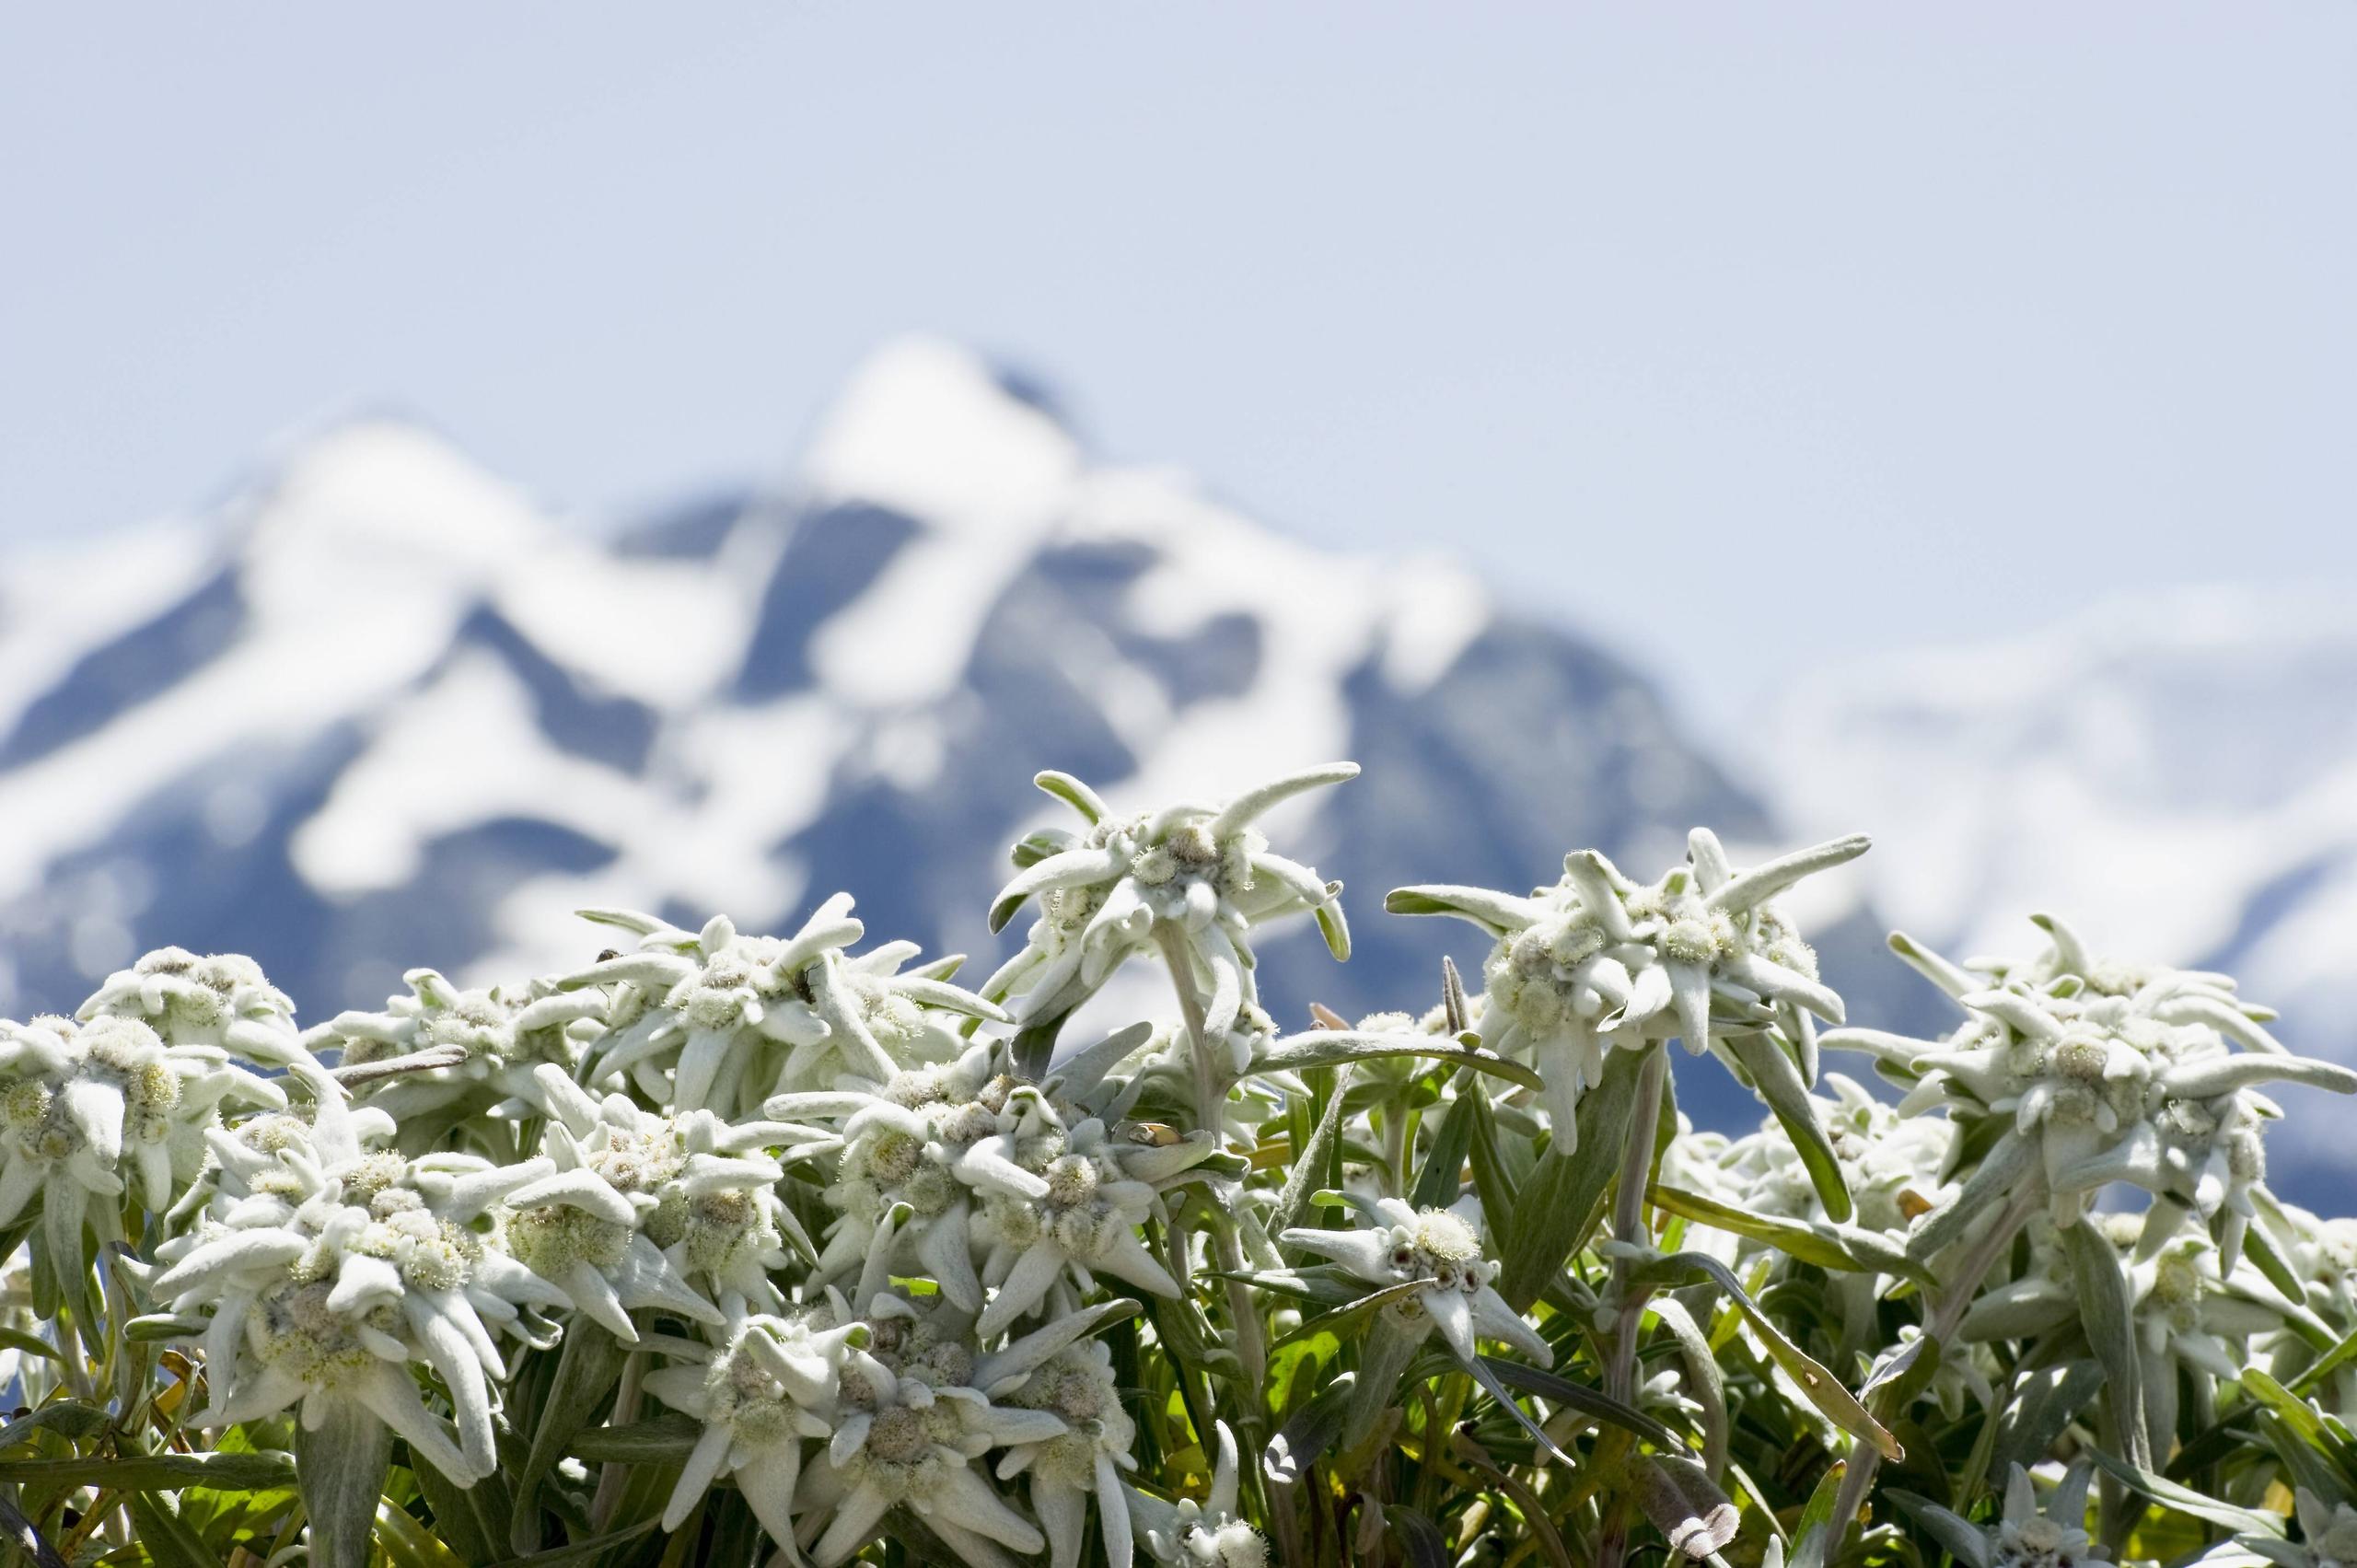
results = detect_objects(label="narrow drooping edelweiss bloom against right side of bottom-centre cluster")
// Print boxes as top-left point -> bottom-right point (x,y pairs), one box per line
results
999,1340 -> 1138,1568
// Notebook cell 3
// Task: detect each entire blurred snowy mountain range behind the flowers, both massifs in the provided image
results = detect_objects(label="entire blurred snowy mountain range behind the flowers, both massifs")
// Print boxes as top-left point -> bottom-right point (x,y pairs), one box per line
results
0,340 -> 2357,1191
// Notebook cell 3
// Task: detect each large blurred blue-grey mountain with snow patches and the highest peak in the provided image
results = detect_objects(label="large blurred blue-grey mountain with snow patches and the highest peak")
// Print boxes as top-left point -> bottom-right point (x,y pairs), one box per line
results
0,340 -> 1895,1132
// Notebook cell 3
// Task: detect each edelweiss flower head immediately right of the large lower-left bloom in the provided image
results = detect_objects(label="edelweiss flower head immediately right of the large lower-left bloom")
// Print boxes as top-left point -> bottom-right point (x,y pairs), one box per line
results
506,1063 -> 834,1344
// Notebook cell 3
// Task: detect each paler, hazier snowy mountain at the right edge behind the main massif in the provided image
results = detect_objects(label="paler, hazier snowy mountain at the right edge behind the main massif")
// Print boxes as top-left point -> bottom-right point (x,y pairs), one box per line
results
1765,587 -> 2357,1172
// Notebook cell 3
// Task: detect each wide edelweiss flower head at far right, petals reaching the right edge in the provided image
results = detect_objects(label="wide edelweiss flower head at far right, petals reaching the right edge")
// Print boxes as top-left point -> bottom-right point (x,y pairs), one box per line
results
1824,915 -> 2357,1260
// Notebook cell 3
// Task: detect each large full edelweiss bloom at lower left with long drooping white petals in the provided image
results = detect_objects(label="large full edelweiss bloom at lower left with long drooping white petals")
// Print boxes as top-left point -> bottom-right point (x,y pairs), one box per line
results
151,1066 -> 565,1485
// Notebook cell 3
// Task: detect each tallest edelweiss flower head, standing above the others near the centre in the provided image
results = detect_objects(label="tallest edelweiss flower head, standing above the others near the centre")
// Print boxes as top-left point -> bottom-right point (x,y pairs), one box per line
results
983,761 -> 1358,1040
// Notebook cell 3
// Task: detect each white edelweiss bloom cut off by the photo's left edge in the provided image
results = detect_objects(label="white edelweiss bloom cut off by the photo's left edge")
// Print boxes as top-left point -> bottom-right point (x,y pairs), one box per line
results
0,1014 -> 285,1292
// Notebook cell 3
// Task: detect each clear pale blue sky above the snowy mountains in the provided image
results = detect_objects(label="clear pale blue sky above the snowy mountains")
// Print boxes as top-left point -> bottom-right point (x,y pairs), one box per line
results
0,0 -> 2357,717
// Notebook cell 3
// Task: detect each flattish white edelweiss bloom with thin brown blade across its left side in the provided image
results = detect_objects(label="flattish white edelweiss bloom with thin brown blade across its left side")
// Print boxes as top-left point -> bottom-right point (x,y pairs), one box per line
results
304,970 -> 606,1146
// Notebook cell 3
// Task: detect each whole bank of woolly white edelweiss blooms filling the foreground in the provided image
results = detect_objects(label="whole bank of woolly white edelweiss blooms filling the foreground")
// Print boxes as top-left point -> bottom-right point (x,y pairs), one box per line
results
0,764 -> 2357,1568
